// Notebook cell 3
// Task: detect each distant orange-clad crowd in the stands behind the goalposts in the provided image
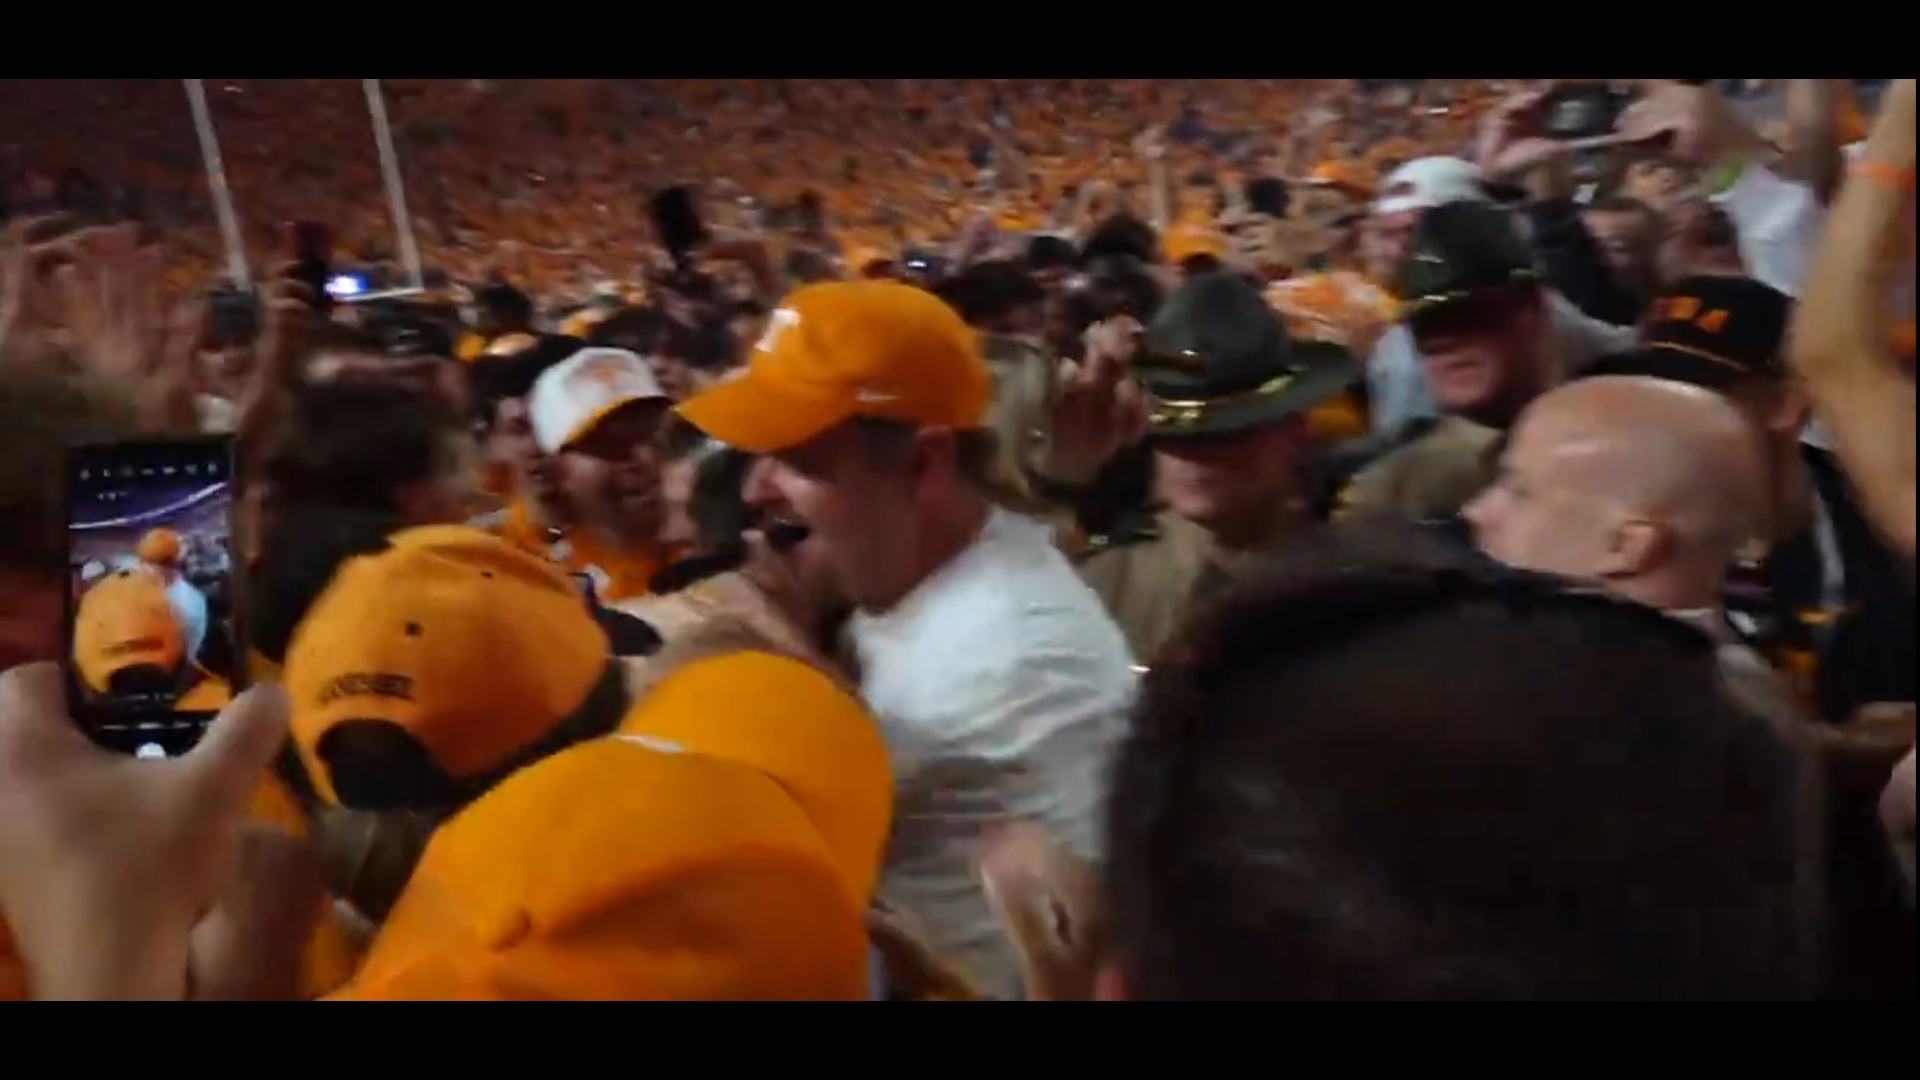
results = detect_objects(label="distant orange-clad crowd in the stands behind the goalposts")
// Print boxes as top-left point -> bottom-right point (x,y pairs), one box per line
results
0,79 -> 1501,300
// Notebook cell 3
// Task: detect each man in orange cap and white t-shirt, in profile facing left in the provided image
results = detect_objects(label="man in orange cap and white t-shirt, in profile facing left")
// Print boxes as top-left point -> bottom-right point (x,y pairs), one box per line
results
680,282 -> 1135,997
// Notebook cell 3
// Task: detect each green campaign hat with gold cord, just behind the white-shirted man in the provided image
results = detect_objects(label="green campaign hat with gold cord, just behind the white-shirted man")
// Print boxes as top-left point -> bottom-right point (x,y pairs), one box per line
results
1135,271 -> 1361,438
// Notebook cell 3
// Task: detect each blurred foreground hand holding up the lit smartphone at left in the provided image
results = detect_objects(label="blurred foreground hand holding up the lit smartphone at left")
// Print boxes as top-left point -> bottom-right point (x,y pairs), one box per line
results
0,665 -> 286,999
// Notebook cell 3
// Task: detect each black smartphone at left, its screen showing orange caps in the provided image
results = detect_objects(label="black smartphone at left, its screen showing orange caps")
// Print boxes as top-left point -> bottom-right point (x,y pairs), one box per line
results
65,436 -> 246,757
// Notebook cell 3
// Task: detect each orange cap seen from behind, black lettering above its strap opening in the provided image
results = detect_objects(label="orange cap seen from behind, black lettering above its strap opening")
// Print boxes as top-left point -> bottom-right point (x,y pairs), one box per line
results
284,527 -> 626,809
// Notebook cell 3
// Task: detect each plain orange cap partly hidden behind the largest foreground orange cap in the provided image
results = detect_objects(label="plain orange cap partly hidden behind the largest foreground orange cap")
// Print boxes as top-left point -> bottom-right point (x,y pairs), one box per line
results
620,651 -> 893,903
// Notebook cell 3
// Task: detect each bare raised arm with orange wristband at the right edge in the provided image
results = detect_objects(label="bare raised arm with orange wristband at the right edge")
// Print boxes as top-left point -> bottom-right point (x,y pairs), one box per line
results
1789,79 -> 1916,571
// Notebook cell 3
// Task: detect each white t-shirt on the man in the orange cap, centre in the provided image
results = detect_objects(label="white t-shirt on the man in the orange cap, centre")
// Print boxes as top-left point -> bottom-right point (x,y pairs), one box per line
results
851,511 -> 1135,997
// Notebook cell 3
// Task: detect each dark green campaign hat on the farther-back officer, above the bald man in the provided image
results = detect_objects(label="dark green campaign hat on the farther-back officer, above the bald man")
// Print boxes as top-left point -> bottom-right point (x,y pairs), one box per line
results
1392,202 -> 1536,321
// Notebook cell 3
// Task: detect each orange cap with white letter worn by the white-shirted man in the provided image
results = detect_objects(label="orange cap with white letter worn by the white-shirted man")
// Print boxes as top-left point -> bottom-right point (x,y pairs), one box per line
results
680,281 -> 993,454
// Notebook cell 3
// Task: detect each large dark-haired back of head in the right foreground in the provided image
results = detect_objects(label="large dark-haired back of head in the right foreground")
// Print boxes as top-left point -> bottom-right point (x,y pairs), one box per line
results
1104,530 -> 1811,999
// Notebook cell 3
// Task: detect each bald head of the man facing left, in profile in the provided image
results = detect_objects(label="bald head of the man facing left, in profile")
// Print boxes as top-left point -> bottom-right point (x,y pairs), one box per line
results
1467,377 -> 1799,726
